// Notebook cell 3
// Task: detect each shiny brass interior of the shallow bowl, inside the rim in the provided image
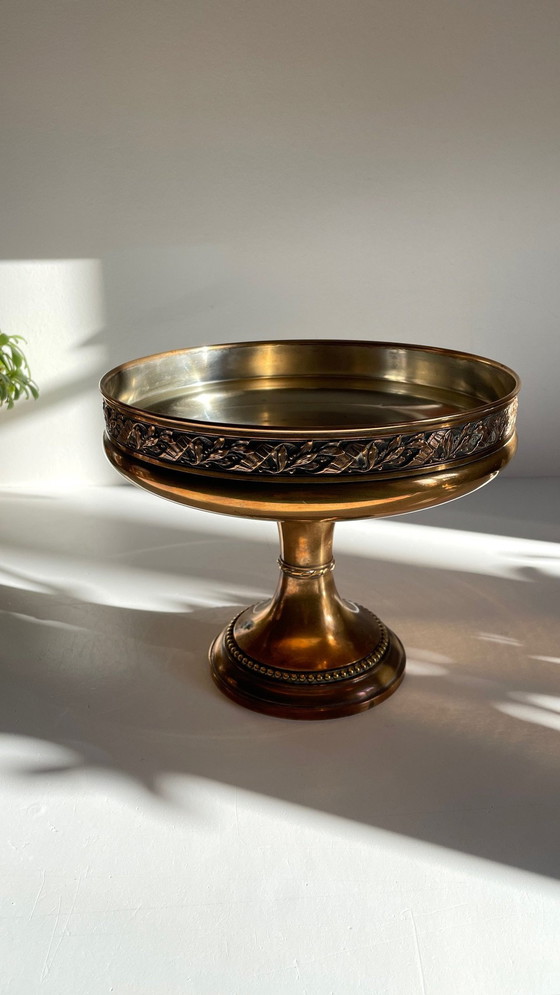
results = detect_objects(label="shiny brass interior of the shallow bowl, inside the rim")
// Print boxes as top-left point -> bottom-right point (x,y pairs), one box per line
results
101,340 -> 519,435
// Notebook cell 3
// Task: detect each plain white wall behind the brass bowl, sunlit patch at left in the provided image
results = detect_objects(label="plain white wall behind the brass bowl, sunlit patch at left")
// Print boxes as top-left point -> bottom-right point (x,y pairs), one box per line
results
0,0 -> 560,485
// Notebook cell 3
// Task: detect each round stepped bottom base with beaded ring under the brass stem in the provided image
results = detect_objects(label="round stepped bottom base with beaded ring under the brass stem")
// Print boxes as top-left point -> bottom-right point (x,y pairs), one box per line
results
210,609 -> 406,719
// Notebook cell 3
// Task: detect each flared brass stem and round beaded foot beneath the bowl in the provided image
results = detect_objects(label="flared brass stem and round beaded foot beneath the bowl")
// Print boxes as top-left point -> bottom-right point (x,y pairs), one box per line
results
210,521 -> 405,719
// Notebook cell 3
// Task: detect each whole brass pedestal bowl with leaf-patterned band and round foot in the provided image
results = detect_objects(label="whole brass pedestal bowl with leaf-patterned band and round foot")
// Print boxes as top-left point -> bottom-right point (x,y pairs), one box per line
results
101,340 -> 519,719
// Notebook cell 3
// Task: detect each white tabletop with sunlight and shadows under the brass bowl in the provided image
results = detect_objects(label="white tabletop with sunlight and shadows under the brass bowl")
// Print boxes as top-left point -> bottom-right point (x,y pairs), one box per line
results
0,480 -> 560,995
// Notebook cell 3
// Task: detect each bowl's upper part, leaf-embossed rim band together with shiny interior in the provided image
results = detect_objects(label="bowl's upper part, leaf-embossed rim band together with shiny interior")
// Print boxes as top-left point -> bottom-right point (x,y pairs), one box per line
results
102,341 -> 518,481
